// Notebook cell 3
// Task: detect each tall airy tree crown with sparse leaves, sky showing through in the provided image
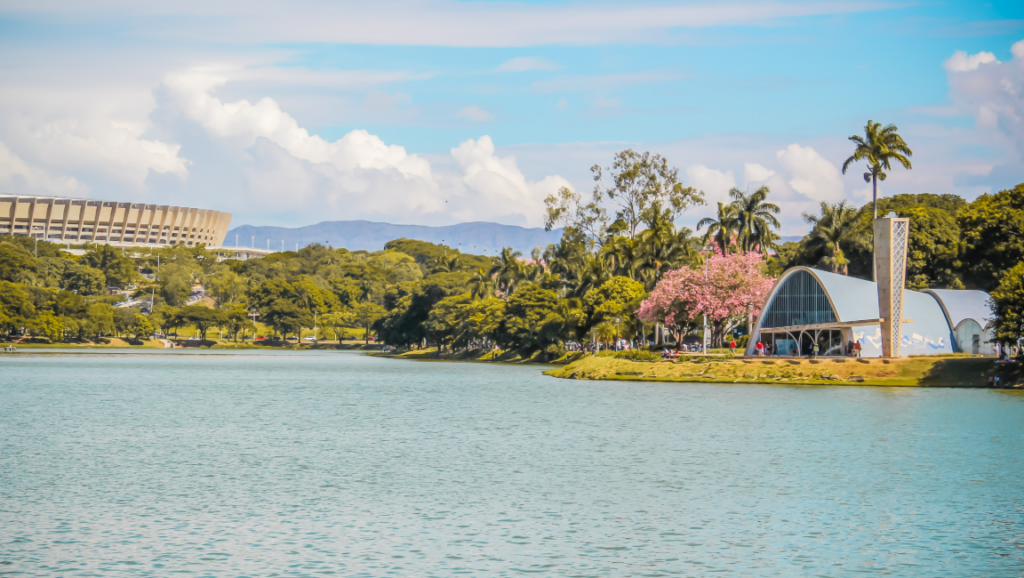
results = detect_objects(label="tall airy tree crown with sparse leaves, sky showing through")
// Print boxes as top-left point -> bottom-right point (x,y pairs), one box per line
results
544,150 -> 705,243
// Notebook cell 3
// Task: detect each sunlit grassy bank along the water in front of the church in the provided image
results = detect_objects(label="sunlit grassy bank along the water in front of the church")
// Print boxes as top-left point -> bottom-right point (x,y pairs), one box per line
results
545,356 -> 1024,387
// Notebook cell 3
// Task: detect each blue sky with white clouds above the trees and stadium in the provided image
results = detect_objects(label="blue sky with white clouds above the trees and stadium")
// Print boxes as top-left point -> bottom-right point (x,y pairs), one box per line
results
0,0 -> 1024,236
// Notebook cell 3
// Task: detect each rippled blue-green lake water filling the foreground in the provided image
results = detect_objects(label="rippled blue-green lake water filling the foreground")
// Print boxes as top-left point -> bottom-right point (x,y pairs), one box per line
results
0,352 -> 1024,577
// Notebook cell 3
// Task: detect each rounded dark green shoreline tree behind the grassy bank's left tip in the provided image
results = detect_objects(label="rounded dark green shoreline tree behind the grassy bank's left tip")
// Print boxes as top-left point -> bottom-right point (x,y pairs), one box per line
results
499,285 -> 566,355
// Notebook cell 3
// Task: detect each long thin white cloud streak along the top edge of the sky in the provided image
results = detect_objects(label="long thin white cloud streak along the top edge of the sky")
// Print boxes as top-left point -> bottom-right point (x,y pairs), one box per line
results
0,0 -> 901,47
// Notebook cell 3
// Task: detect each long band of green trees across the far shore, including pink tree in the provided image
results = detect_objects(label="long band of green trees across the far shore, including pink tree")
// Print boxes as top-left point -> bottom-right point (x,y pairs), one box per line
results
0,175 -> 1024,356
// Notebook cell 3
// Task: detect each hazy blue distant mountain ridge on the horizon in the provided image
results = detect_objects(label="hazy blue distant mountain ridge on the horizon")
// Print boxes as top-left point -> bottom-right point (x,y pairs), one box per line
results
224,220 -> 562,254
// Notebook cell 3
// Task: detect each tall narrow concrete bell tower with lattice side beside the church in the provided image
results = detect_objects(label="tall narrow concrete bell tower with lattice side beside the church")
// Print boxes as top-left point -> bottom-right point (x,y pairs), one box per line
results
874,213 -> 910,359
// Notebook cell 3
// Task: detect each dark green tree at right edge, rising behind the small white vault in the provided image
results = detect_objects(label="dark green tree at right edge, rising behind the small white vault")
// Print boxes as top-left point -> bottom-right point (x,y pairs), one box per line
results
957,183 -> 1024,291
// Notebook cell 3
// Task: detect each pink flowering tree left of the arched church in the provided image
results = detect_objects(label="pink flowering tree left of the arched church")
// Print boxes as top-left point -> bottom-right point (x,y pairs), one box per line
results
637,249 -> 775,346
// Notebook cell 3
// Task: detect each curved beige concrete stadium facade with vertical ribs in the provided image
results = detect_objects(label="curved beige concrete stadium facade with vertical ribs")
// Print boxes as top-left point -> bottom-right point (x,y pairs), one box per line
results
0,195 -> 231,248
